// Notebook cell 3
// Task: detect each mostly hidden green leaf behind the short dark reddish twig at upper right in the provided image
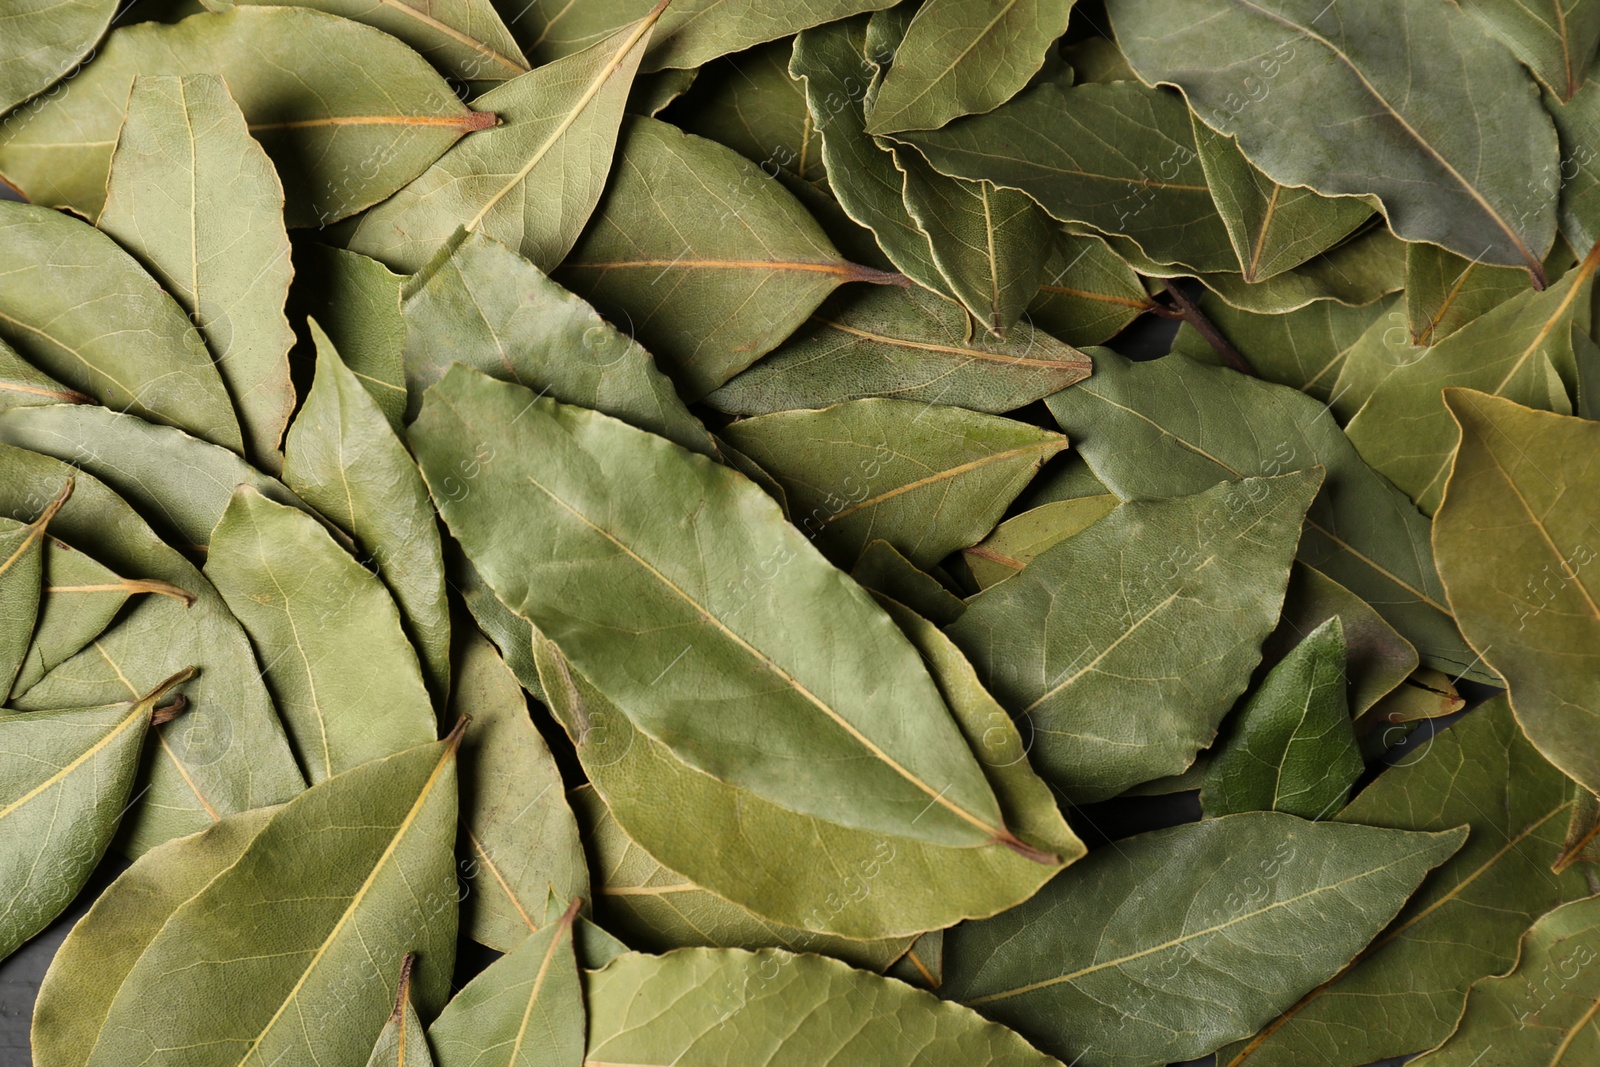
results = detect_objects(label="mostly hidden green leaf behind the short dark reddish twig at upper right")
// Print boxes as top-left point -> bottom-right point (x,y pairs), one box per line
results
1173,292 -> 1395,400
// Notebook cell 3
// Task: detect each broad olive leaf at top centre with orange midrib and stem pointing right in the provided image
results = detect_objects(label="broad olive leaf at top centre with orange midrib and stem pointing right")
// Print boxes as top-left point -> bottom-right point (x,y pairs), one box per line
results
557,117 -> 899,400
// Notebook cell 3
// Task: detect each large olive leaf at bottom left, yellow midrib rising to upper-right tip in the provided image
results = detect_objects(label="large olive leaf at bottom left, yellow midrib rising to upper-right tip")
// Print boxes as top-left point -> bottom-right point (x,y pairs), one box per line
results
88,736 -> 459,1067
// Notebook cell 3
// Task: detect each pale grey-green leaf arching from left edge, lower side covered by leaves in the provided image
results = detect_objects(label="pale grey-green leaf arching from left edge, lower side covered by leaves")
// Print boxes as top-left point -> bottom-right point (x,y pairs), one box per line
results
0,405 -> 306,552
